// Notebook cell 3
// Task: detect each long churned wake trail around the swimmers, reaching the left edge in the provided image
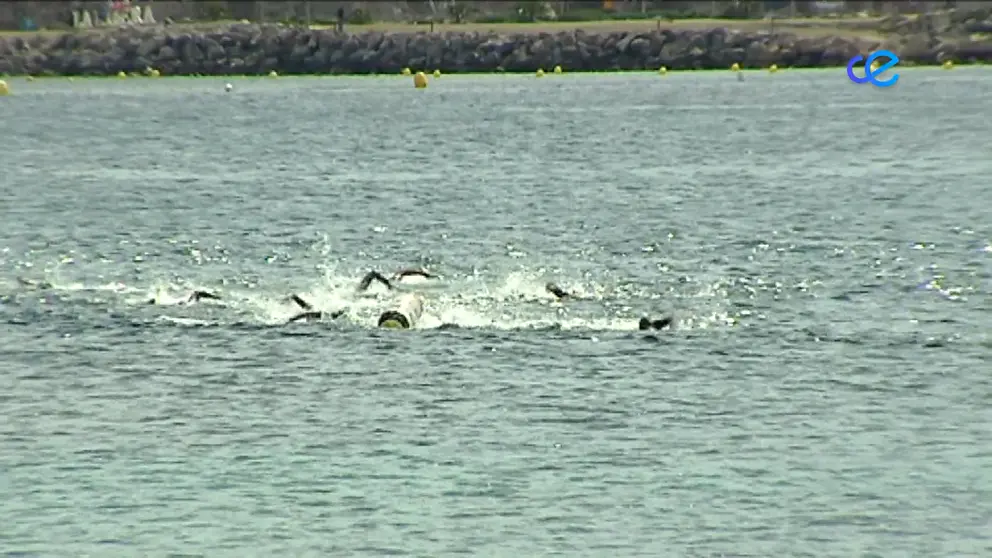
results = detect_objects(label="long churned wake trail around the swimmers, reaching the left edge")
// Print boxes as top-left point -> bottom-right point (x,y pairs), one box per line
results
0,270 -> 740,331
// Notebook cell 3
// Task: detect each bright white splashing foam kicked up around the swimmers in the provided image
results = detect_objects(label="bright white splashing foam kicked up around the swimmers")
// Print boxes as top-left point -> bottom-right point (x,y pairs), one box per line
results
5,269 -> 737,331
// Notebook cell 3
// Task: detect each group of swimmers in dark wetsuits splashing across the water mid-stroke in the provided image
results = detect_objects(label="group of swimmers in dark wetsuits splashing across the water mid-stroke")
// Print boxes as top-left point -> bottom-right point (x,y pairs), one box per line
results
20,268 -> 674,330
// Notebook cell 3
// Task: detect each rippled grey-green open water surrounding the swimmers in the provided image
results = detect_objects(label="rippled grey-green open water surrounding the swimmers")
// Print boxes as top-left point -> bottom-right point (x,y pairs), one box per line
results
0,68 -> 992,557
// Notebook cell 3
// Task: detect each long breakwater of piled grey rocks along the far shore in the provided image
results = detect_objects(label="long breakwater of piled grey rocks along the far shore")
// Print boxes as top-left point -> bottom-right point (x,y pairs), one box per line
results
0,24 -> 992,75
